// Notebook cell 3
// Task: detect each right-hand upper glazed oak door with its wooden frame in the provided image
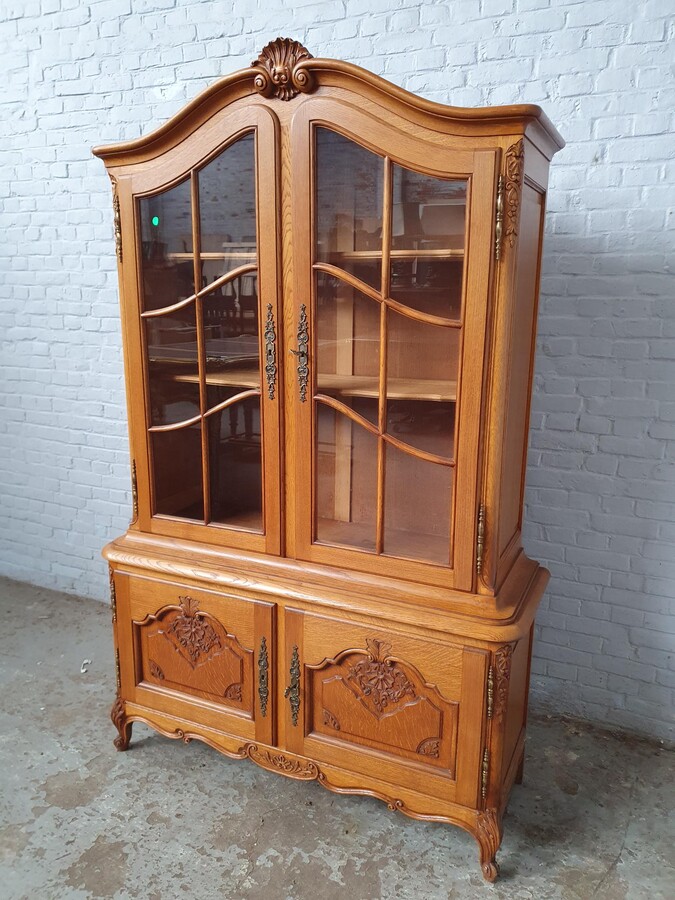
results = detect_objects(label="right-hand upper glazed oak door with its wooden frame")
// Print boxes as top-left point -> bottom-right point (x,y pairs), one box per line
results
294,104 -> 495,587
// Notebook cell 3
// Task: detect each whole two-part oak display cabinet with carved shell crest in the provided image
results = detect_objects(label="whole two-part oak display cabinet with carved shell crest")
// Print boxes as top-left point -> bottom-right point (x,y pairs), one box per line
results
94,39 -> 563,881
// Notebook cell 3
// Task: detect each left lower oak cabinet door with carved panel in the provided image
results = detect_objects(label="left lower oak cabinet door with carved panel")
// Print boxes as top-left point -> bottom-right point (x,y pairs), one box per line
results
115,573 -> 275,743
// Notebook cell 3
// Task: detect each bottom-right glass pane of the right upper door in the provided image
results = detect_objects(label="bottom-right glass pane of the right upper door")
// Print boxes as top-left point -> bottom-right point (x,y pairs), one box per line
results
384,444 -> 454,565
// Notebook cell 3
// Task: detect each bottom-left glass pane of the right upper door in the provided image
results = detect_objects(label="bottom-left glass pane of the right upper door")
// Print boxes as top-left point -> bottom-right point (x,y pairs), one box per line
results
316,403 -> 377,551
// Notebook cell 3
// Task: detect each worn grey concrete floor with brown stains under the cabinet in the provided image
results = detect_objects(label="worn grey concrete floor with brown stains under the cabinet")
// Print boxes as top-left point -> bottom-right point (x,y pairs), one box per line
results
0,579 -> 675,900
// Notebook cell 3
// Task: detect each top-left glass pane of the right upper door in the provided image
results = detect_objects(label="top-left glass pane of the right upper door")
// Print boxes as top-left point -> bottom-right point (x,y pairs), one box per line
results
315,128 -> 384,290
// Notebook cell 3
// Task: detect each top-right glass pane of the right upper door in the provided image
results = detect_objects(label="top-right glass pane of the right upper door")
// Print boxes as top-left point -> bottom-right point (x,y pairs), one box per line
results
390,165 -> 466,319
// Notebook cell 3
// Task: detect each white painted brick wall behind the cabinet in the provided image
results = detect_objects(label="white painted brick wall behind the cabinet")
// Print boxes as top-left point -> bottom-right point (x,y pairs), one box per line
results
0,0 -> 675,738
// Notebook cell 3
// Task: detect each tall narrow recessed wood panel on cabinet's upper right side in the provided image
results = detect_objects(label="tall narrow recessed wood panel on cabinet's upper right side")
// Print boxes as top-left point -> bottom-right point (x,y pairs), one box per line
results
499,183 -> 545,560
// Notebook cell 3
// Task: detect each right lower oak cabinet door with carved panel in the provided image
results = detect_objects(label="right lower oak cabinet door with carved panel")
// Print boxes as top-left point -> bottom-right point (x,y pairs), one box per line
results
283,609 -> 489,806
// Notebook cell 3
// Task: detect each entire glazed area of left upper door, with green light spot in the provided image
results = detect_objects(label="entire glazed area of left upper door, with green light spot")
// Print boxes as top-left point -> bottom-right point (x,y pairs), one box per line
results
139,132 -> 266,533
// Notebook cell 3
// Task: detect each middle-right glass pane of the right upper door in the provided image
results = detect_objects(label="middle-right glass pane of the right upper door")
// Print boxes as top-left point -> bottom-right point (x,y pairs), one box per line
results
387,309 -> 460,459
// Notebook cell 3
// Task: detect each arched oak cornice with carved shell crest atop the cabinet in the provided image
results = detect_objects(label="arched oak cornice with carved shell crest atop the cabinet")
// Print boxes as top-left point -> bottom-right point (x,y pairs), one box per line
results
92,38 -> 565,167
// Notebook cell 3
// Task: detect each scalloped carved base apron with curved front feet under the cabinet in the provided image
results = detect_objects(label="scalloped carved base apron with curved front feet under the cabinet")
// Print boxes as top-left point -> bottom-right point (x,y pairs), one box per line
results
110,696 -> 503,882
